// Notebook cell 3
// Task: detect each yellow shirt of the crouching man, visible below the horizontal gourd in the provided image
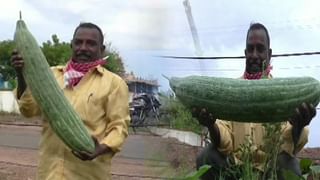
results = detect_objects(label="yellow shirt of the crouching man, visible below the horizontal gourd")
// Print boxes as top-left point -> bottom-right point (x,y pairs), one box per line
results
216,75 -> 309,169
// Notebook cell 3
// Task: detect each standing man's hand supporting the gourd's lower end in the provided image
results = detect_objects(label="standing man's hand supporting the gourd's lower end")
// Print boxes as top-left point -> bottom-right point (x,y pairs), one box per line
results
71,137 -> 112,161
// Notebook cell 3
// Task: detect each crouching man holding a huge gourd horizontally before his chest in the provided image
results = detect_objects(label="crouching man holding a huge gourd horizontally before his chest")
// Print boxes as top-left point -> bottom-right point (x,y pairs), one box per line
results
193,23 -> 316,179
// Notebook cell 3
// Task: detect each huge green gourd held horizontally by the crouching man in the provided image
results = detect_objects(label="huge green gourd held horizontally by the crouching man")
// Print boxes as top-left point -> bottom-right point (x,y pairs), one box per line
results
169,76 -> 320,123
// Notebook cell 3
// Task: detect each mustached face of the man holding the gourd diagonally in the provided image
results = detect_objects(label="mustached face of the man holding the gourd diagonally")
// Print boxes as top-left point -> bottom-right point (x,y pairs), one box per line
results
71,28 -> 104,63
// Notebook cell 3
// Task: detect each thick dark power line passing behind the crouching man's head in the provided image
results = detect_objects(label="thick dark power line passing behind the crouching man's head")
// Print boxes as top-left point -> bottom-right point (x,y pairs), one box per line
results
157,51 -> 320,59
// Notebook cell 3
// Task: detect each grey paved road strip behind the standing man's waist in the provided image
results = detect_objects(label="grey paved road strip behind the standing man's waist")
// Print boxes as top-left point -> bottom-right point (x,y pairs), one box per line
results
0,125 -> 166,161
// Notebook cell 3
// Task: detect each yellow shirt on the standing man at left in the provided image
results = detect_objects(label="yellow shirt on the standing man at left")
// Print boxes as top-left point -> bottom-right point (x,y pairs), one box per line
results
15,66 -> 130,180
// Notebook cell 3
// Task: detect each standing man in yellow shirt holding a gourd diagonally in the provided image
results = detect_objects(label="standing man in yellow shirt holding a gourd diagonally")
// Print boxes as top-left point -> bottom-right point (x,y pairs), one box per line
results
11,23 -> 130,180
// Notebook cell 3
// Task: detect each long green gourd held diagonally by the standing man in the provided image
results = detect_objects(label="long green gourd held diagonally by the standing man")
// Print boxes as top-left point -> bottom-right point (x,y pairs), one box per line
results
14,14 -> 94,153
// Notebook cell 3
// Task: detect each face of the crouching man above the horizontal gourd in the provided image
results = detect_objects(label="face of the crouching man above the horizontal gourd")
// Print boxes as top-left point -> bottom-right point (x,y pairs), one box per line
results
245,29 -> 271,74
